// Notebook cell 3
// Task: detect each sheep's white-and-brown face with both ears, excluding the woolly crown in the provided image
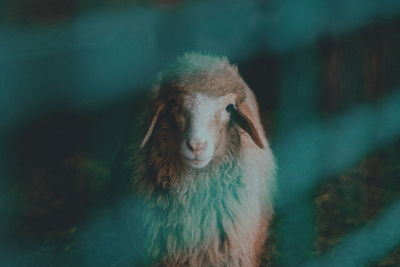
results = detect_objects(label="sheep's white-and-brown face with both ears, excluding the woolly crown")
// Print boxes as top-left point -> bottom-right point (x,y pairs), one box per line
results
141,88 -> 264,169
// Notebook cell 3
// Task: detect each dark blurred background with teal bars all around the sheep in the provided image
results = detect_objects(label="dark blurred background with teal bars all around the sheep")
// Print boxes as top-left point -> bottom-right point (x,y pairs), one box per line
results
0,0 -> 400,267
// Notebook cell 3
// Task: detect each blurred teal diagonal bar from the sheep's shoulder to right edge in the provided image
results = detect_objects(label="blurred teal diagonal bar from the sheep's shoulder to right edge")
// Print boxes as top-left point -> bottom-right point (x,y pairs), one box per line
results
275,90 -> 400,207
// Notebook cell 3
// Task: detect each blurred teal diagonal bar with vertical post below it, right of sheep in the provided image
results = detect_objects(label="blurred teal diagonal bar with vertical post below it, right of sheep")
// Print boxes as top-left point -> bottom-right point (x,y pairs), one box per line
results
274,90 -> 400,265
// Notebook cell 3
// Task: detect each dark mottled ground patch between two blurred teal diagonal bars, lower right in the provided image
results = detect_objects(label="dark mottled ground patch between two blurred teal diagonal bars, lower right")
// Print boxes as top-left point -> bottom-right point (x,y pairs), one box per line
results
315,141 -> 400,256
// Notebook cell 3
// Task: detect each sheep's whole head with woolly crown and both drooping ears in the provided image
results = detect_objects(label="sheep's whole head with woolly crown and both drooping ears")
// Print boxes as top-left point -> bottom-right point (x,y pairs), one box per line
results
141,54 -> 263,169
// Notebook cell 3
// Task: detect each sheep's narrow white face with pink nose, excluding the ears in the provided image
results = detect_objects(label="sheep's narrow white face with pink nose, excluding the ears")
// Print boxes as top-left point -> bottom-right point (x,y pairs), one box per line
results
176,93 -> 235,169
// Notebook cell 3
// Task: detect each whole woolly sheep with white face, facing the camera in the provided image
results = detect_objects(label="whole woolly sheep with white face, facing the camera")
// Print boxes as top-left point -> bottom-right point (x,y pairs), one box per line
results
132,52 -> 276,266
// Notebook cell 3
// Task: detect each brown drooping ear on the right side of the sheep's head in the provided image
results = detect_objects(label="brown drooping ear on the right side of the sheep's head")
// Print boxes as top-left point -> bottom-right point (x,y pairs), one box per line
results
232,103 -> 265,148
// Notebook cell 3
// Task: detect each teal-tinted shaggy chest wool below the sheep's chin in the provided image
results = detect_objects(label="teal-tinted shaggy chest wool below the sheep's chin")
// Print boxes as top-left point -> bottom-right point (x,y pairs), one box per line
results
142,160 -> 244,256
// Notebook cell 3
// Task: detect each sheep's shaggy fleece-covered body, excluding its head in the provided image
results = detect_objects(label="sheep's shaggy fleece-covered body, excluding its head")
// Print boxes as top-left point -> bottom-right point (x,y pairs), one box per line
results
134,53 -> 275,266
